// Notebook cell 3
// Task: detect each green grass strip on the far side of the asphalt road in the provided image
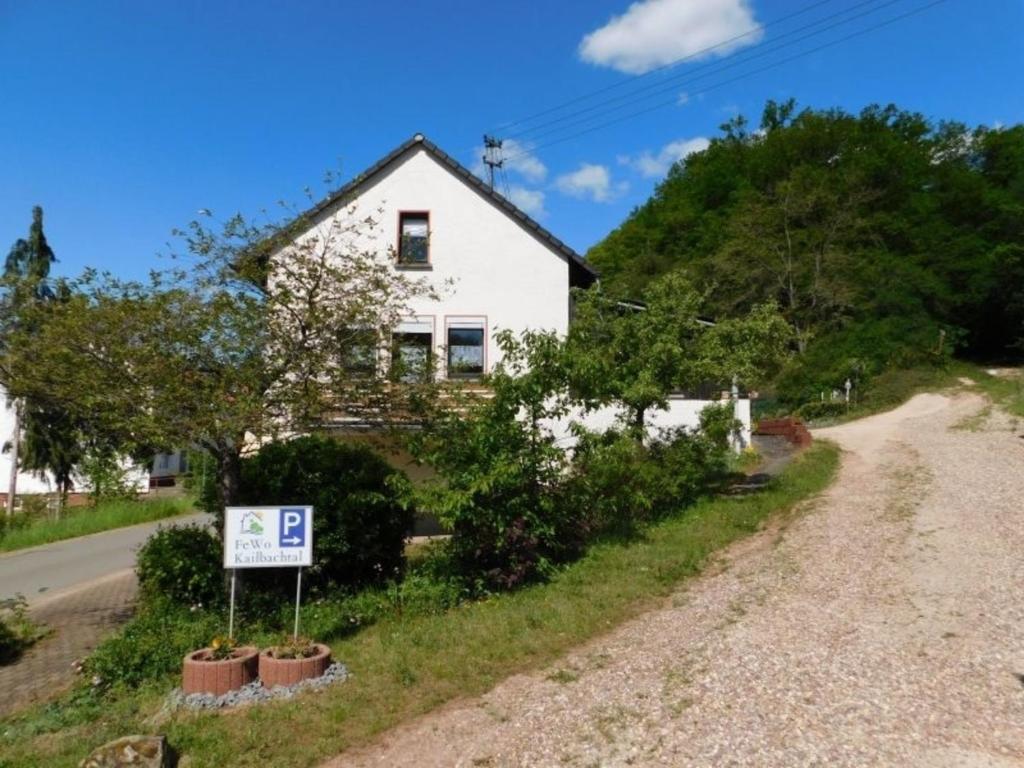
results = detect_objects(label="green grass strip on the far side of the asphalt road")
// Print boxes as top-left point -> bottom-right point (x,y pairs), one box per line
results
0,498 -> 193,552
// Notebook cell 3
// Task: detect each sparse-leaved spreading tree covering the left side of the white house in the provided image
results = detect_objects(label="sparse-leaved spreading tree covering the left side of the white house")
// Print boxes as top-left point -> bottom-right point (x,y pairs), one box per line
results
0,205 -> 430,520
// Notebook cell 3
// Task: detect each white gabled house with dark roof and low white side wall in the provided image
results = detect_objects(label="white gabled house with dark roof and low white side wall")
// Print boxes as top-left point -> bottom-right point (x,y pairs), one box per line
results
276,133 -> 750,450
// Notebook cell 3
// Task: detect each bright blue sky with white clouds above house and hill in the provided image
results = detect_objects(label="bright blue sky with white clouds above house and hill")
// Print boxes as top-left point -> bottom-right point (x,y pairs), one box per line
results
0,0 -> 1024,276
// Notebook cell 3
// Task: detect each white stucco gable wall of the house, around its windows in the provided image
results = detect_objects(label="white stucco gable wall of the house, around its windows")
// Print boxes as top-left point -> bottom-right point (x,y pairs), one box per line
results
292,148 -> 569,375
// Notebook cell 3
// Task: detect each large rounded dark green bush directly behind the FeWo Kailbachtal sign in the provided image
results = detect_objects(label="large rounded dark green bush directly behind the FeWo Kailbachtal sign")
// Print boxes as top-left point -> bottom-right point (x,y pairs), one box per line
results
241,436 -> 414,593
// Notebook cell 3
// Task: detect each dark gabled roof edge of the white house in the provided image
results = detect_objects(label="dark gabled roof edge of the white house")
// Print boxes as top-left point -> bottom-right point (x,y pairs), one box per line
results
306,133 -> 598,286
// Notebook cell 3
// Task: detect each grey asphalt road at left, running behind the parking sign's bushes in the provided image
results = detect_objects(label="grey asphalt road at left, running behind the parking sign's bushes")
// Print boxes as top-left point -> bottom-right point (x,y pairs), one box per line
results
0,513 -> 210,605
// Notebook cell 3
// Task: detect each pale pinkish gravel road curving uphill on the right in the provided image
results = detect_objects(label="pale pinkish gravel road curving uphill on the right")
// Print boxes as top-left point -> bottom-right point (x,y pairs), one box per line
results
329,394 -> 1024,768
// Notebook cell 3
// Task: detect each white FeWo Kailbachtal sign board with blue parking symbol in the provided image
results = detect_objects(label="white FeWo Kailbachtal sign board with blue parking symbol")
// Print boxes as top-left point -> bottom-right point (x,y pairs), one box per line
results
224,506 -> 313,568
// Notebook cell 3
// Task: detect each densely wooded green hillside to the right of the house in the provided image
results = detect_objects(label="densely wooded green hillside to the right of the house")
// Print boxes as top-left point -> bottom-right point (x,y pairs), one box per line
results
588,101 -> 1024,402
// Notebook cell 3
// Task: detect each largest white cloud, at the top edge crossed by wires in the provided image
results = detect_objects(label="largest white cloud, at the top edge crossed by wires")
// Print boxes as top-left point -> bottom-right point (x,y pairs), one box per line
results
579,0 -> 764,75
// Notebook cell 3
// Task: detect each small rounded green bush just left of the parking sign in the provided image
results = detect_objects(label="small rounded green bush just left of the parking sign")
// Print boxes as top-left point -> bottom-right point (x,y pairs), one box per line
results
135,525 -> 224,605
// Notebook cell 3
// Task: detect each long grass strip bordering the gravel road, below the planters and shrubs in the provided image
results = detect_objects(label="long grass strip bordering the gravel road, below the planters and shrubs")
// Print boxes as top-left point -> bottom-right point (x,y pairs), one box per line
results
0,442 -> 839,768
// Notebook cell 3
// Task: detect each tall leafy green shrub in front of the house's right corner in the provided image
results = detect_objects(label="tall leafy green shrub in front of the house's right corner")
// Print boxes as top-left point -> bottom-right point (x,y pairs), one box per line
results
411,332 -> 583,591
